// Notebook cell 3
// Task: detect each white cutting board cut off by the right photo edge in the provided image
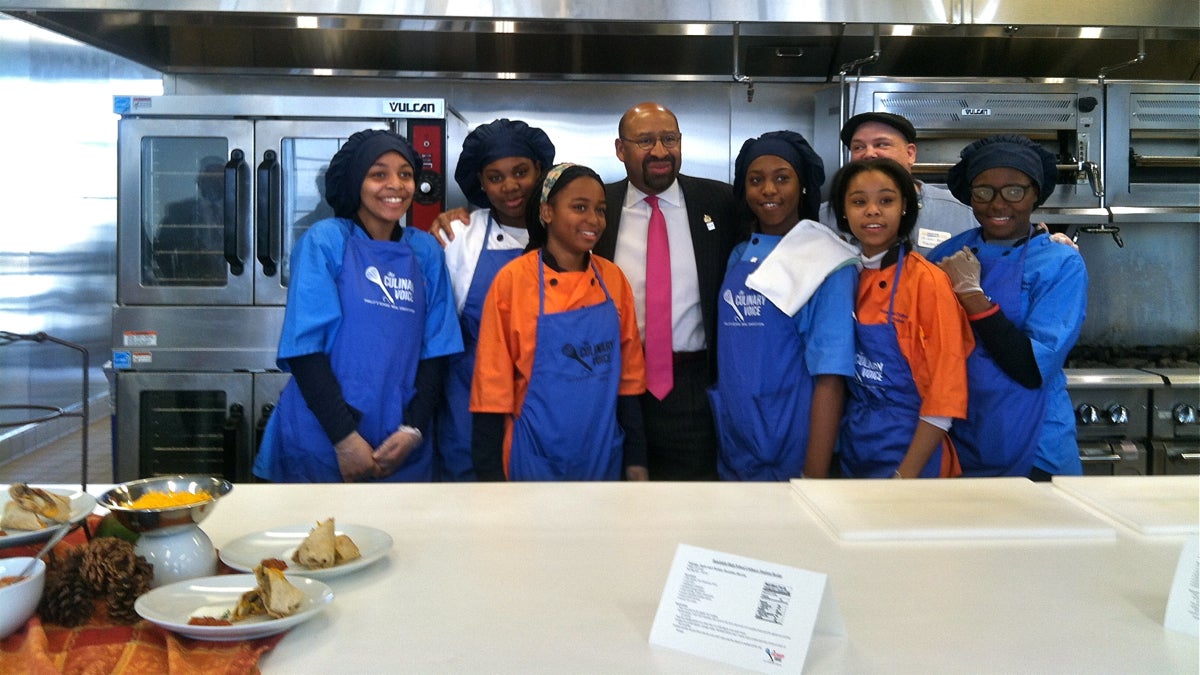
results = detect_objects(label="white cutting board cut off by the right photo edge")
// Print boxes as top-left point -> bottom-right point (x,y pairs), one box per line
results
1054,476 -> 1200,534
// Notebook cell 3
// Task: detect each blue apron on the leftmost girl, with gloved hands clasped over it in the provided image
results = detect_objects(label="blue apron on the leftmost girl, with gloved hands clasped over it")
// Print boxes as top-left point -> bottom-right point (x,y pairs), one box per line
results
265,230 -> 433,483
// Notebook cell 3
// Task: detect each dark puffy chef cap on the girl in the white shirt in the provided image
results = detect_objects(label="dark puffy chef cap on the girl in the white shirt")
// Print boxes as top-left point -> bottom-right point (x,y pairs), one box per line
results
454,119 -> 554,209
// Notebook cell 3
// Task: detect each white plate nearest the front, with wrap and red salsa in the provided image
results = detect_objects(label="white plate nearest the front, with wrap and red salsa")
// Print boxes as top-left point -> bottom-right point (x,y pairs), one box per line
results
133,574 -> 334,641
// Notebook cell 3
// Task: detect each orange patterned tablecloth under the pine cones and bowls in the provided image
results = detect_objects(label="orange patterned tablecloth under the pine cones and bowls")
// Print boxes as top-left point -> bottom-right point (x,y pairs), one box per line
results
0,516 -> 283,675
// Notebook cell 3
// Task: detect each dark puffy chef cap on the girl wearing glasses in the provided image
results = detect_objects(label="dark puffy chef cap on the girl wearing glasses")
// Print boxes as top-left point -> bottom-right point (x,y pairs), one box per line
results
946,133 -> 1058,208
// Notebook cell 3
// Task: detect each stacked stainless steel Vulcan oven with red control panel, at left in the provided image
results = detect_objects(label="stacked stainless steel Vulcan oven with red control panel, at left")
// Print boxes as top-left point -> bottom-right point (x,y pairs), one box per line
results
112,95 -> 463,480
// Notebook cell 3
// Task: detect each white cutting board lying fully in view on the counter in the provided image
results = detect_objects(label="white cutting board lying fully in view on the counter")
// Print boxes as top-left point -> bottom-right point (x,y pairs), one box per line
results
792,478 -> 1116,540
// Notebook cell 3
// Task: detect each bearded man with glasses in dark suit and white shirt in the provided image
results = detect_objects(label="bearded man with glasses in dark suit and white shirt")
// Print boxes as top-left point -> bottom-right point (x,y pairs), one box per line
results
594,102 -> 745,480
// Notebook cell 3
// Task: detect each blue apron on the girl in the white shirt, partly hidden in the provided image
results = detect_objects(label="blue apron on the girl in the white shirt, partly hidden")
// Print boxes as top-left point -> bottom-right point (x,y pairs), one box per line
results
434,214 -> 522,482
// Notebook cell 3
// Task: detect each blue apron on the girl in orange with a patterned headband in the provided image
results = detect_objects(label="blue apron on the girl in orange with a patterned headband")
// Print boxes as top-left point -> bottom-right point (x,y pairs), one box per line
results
509,251 -> 625,480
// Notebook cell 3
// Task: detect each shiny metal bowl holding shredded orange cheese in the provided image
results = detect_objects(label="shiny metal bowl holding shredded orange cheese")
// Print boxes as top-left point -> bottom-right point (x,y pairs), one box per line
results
100,476 -> 233,532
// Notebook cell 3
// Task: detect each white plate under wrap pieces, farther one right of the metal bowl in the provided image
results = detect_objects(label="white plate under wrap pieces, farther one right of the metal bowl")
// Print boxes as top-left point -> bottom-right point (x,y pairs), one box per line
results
220,522 -> 391,579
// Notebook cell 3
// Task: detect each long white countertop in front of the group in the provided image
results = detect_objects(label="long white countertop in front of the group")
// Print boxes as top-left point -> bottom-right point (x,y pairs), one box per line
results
117,477 -> 1198,674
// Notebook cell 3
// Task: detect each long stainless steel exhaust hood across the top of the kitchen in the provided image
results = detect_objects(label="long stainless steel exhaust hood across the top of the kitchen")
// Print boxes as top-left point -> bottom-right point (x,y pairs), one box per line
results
0,0 -> 1200,82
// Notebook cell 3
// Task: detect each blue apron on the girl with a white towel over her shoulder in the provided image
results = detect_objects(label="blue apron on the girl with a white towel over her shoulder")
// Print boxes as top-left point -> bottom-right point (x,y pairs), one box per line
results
708,234 -> 814,480
